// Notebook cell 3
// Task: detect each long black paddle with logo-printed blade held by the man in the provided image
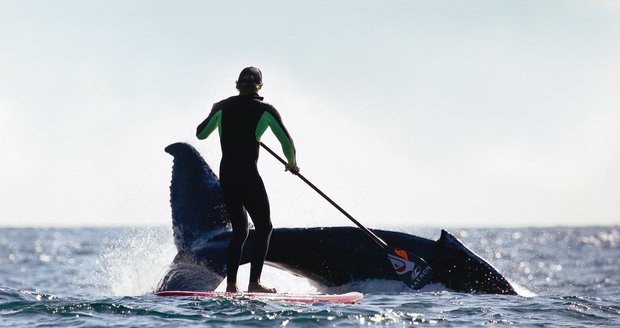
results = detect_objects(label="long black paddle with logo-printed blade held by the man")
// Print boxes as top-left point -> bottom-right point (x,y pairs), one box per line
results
260,142 -> 433,289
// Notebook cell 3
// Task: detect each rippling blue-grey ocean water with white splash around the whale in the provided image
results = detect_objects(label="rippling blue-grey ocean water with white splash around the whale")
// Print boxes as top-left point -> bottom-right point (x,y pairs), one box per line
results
0,226 -> 620,327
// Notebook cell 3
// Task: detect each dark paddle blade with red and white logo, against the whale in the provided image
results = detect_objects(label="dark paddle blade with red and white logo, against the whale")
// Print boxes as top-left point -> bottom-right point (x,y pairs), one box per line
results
388,247 -> 433,289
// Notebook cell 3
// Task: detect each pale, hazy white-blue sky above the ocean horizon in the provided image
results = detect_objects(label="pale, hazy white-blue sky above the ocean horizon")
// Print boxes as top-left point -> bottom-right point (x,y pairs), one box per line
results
0,0 -> 620,228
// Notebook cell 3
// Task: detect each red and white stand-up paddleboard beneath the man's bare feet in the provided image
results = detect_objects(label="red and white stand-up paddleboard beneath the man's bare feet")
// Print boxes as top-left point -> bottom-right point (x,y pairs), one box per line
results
155,291 -> 364,303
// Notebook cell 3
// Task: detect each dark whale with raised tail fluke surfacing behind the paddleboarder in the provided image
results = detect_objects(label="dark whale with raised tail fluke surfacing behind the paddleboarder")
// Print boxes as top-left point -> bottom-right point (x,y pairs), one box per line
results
156,142 -> 517,295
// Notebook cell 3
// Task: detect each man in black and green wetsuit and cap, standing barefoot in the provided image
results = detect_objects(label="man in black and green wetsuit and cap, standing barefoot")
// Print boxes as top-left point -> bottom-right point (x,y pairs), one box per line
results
196,67 -> 299,293
